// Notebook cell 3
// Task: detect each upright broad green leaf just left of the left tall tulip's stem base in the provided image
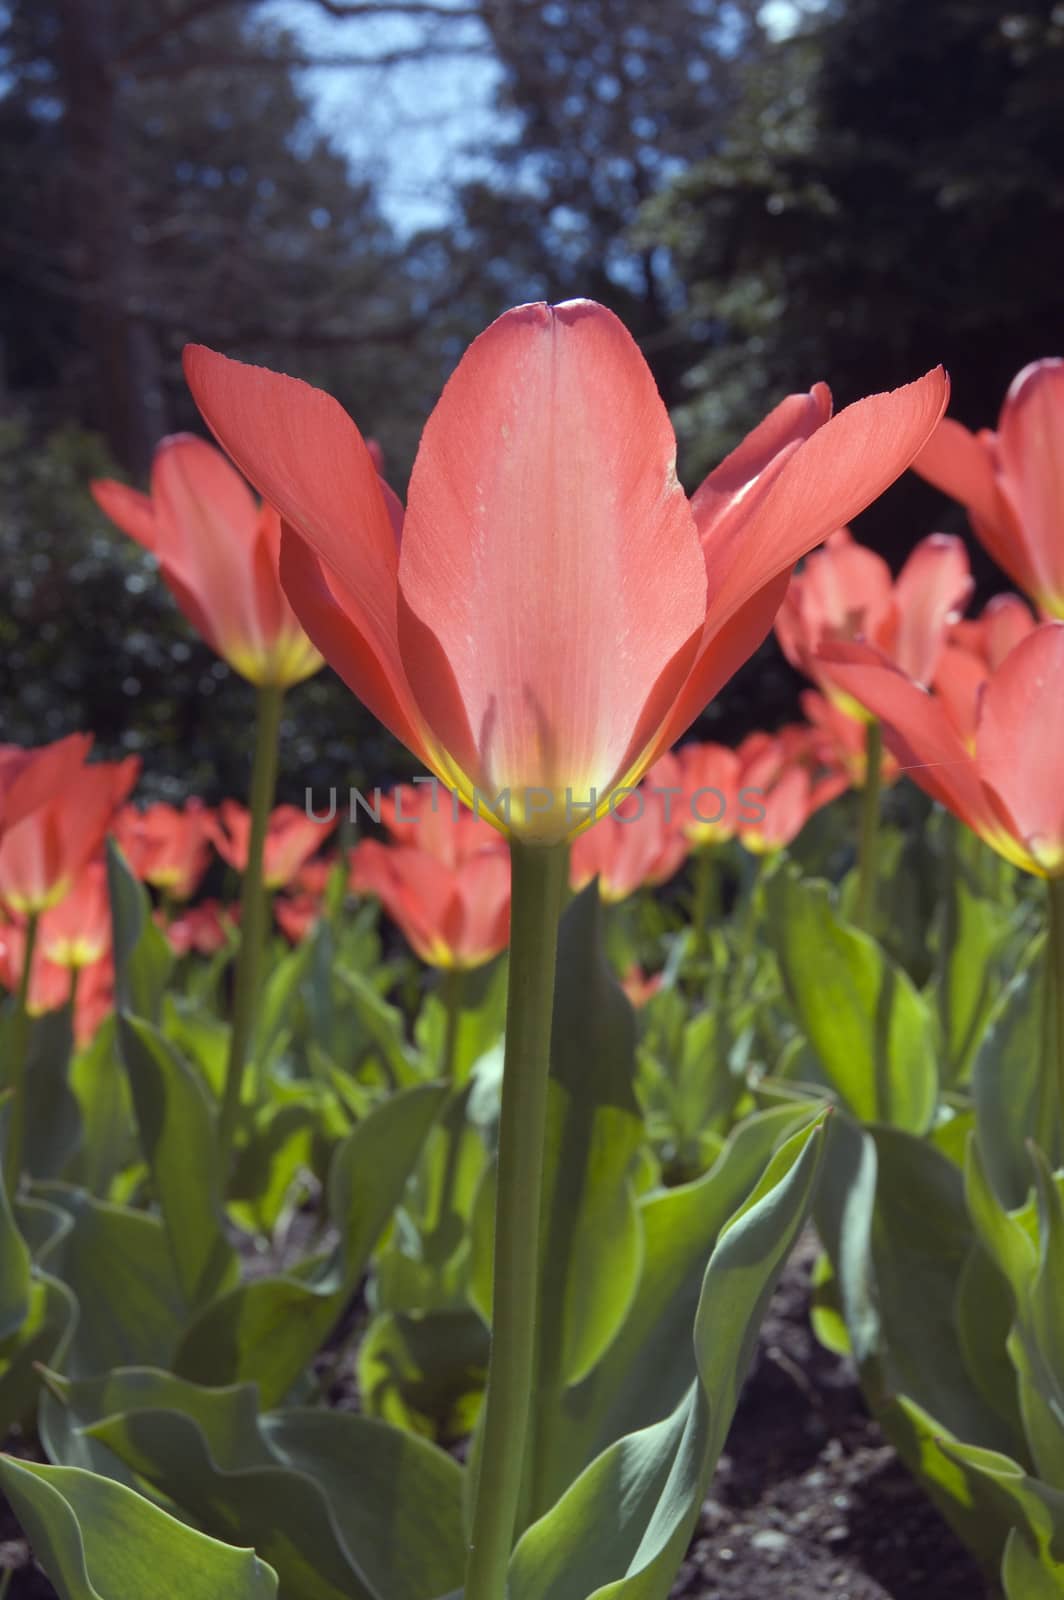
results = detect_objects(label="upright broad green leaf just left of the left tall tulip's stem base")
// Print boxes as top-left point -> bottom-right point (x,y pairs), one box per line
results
118,1014 -> 238,1310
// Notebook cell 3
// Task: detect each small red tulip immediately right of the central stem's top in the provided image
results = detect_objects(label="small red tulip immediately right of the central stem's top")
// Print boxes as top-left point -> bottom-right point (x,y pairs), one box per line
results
570,784 -> 688,904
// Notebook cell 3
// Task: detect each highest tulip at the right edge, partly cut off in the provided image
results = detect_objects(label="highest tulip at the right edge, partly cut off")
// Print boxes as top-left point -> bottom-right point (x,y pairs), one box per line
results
914,358 -> 1064,618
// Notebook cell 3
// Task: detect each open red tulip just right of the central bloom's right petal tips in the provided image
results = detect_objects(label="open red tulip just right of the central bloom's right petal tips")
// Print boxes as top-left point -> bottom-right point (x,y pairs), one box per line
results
776,528 -> 973,714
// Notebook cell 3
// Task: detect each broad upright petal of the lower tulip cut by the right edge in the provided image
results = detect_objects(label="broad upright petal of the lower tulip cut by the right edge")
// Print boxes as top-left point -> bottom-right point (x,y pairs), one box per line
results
976,622 -> 1064,877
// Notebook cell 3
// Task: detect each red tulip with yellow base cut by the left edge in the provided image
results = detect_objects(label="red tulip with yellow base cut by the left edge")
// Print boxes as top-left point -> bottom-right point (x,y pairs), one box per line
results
0,734 -> 141,915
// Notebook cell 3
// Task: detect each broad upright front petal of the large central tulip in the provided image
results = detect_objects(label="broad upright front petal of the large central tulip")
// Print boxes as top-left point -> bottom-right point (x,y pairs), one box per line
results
393,302 -> 706,795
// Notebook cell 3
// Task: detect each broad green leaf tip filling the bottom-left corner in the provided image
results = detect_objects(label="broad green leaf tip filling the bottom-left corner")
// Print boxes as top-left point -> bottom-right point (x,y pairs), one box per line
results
0,1458 -> 277,1600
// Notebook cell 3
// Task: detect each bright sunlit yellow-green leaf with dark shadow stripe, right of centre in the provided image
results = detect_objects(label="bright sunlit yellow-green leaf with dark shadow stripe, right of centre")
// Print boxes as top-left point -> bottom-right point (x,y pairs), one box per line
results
765,869 -> 938,1133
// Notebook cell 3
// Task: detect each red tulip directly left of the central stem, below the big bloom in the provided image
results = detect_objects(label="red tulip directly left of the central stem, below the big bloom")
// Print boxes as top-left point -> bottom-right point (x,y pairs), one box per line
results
350,838 -> 510,970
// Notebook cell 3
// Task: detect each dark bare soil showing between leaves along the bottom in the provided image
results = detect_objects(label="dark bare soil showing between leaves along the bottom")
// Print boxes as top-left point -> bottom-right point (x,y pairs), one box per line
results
0,1238 -> 986,1600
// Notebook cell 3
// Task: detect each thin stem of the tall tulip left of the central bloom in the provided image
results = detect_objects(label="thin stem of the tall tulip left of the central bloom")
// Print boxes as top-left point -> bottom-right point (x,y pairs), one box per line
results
218,683 -> 285,1186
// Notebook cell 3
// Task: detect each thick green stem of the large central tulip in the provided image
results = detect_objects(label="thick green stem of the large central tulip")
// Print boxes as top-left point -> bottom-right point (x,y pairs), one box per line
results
464,840 -> 568,1600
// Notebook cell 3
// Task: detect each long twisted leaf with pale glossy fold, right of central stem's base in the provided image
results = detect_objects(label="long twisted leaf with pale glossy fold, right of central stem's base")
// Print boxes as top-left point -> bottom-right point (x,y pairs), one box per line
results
509,1126 -> 822,1600
